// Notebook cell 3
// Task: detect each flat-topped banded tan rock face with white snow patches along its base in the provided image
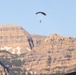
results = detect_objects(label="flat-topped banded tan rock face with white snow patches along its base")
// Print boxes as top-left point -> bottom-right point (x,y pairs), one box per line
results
0,25 -> 33,54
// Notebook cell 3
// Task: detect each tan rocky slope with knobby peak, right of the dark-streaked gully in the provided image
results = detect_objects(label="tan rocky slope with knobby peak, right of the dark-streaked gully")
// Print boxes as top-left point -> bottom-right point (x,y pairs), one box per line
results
25,34 -> 76,74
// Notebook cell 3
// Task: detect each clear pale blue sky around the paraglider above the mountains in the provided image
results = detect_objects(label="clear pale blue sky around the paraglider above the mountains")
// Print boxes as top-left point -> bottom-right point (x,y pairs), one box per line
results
0,0 -> 76,37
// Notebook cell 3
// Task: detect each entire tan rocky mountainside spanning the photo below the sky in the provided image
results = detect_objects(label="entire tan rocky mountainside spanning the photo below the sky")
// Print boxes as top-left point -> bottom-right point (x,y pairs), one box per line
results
0,25 -> 76,75
